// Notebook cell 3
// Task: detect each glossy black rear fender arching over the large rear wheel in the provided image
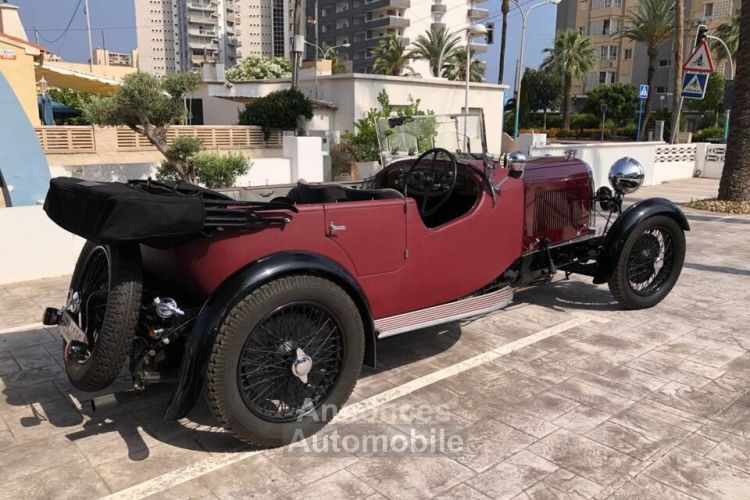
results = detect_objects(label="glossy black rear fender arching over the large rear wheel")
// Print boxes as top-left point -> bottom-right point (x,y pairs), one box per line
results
165,252 -> 376,420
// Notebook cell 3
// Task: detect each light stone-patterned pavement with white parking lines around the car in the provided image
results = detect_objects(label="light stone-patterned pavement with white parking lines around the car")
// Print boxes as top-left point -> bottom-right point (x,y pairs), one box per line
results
0,181 -> 750,499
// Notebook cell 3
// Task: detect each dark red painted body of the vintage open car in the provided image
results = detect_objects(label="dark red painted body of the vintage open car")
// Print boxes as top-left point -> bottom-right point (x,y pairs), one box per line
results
143,158 -> 592,320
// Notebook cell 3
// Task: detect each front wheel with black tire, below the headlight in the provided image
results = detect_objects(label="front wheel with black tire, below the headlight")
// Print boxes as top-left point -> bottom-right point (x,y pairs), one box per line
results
608,215 -> 685,309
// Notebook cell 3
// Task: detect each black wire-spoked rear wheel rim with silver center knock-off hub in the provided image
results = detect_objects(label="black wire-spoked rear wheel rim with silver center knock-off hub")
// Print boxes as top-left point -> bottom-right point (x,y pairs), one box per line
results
237,302 -> 345,422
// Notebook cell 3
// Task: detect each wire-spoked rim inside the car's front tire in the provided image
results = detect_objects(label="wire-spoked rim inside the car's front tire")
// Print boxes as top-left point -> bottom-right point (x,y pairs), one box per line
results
627,228 -> 674,296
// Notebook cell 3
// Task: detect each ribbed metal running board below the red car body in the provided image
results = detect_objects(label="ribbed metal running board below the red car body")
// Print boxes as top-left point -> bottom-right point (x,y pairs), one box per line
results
375,286 -> 513,339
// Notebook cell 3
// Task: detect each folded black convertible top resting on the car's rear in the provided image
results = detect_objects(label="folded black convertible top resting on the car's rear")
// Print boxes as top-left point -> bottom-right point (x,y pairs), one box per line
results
44,177 -> 297,246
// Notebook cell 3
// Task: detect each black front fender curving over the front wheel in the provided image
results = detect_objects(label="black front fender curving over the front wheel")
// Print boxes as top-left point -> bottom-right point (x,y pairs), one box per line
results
594,198 -> 690,284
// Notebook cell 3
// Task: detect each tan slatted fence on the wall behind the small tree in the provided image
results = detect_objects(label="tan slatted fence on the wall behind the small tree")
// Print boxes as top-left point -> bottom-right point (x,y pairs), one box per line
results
117,125 -> 281,151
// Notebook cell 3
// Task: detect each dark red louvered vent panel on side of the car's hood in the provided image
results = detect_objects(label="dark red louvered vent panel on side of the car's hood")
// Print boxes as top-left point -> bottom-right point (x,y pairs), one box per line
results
533,187 -> 589,234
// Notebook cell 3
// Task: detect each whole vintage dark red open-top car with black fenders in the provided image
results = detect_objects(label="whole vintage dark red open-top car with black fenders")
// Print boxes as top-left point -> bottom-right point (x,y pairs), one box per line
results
45,115 -> 689,446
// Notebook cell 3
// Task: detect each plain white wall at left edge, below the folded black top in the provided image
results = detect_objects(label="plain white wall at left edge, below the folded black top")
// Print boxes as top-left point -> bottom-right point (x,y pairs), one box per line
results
0,206 -> 83,284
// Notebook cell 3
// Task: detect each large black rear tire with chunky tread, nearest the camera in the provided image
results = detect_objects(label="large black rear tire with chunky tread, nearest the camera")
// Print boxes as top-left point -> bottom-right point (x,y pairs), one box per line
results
206,275 -> 364,448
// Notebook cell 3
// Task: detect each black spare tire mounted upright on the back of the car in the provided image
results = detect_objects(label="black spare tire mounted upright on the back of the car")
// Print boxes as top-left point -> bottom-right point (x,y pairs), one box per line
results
65,241 -> 142,392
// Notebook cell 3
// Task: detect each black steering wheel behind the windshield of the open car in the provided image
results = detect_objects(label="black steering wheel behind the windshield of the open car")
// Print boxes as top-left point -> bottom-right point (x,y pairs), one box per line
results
404,148 -> 458,217
